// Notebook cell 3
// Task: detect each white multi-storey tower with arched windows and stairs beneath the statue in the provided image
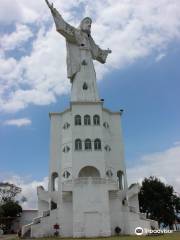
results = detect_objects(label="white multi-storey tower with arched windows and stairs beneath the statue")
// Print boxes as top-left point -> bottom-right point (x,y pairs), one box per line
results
23,101 -> 156,237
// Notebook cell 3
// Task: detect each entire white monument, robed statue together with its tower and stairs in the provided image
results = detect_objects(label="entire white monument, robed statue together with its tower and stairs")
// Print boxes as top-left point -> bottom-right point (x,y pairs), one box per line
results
23,1 -> 158,237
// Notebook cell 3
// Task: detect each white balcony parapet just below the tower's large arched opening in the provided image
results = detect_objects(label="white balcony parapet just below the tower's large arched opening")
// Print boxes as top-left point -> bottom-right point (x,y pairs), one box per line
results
62,177 -> 118,192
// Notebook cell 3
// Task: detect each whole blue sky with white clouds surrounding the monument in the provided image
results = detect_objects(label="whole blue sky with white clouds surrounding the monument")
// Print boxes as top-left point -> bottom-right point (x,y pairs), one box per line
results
0,0 -> 180,208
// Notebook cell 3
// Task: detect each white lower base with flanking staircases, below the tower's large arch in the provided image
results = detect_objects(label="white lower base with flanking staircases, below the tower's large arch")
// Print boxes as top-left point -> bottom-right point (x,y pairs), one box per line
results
22,183 -> 158,238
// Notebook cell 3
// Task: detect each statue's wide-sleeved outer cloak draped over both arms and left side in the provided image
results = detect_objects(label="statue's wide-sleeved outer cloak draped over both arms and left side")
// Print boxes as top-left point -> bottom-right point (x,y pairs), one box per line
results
52,9 -> 108,82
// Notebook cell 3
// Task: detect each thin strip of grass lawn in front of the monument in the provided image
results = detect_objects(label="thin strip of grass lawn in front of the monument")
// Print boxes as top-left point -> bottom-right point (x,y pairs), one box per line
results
8,232 -> 180,240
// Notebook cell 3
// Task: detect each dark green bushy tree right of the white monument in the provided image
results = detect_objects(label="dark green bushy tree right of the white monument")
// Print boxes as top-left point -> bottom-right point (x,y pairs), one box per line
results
139,176 -> 180,227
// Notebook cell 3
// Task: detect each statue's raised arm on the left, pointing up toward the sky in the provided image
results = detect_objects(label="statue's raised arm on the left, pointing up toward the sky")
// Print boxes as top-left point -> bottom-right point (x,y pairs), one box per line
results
45,0 -> 76,42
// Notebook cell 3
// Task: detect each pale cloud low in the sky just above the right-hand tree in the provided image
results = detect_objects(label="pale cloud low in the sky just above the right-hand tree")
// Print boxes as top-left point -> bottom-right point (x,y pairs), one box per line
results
127,145 -> 180,193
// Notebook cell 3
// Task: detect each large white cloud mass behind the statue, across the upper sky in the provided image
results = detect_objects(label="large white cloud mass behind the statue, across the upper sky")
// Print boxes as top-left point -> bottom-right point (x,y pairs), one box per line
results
0,0 -> 180,112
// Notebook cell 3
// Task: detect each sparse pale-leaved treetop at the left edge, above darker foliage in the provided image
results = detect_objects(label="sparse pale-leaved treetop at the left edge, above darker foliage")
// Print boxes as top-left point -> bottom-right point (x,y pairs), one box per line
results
0,182 -> 21,204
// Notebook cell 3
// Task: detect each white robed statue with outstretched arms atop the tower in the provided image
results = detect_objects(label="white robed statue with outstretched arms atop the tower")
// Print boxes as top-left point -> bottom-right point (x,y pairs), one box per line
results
45,0 -> 111,101
